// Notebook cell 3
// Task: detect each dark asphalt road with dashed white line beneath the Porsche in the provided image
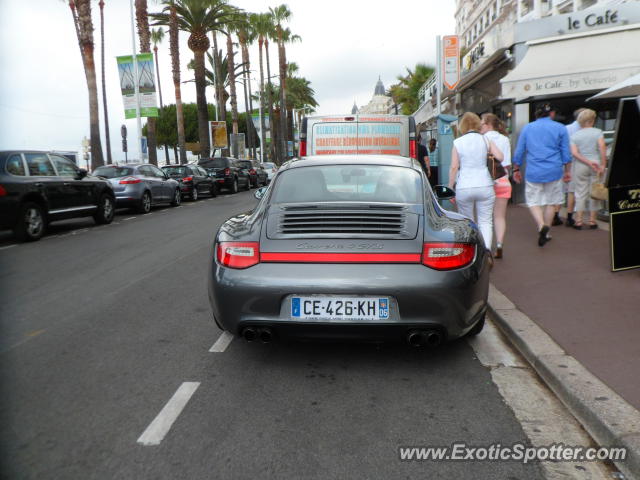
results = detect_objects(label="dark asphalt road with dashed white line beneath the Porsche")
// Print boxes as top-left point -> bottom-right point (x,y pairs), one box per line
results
0,192 -> 542,480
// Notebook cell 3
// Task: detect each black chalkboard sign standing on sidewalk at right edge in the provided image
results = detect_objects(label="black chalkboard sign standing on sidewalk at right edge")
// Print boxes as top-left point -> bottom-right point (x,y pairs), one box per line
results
607,98 -> 640,272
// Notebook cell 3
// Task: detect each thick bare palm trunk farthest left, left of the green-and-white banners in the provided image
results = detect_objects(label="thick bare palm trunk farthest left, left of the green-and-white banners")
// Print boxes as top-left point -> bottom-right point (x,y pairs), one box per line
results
69,0 -> 104,170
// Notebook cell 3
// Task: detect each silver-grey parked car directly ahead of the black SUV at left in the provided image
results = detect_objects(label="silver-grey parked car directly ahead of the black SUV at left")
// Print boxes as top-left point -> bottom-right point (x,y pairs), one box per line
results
93,163 -> 182,213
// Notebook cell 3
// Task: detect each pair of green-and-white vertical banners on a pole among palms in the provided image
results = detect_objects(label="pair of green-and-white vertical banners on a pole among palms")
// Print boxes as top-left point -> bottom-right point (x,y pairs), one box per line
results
116,53 -> 158,118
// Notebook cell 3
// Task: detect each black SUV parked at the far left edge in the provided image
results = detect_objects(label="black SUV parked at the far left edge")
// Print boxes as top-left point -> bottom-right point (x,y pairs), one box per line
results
0,151 -> 115,241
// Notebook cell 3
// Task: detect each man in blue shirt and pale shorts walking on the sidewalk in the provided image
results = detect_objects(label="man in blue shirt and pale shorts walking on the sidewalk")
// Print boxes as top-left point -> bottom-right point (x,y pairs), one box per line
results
513,104 -> 571,247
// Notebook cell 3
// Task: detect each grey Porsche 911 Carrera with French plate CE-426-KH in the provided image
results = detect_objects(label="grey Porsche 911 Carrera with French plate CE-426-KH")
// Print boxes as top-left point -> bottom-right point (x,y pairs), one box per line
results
208,155 -> 491,346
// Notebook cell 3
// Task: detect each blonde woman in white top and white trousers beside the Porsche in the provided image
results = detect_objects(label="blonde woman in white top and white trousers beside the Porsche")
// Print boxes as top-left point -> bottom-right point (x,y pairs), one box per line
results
449,112 -> 503,250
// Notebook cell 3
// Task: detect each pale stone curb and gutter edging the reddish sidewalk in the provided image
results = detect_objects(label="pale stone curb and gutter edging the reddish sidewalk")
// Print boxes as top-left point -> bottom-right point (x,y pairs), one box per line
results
489,284 -> 640,480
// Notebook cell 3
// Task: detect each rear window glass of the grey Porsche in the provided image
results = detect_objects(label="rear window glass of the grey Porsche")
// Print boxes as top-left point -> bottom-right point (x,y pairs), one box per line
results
272,165 -> 422,203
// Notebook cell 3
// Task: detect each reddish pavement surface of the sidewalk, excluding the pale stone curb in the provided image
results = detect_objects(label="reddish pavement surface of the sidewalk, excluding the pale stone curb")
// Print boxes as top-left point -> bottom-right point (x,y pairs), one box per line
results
491,206 -> 640,410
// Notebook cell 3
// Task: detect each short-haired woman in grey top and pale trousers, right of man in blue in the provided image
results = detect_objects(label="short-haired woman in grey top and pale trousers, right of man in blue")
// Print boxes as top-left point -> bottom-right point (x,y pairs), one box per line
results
570,108 -> 607,230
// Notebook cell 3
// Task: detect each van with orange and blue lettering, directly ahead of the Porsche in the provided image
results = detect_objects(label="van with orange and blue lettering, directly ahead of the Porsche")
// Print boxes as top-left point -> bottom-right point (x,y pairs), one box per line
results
300,114 -> 417,158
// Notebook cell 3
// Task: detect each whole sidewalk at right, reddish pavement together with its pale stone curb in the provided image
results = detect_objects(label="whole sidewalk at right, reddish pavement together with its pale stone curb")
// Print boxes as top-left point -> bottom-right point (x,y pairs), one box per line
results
489,206 -> 640,478
